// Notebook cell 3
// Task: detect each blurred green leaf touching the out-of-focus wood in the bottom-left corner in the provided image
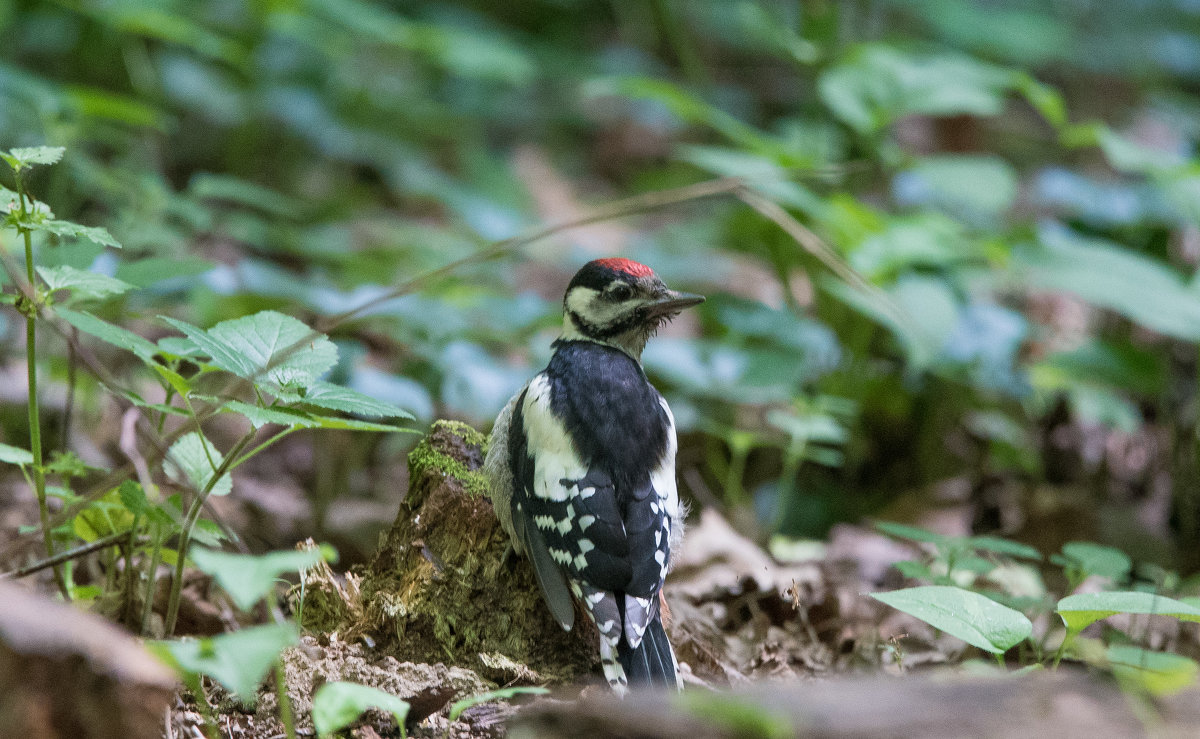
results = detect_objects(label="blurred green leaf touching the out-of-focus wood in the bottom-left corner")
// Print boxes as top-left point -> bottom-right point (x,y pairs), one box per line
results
148,621 -> 300,703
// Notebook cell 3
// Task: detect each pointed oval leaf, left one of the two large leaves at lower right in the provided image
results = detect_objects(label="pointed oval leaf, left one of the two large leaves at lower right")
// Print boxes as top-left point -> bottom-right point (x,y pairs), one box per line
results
871,585 -> 1033,654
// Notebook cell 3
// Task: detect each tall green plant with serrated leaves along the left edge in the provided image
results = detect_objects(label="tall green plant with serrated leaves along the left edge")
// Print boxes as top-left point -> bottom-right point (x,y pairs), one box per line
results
0,146 -> 412,636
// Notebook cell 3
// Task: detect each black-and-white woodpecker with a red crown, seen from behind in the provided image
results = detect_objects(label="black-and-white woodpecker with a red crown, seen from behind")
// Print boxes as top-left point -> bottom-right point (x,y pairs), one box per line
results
484,258 -> 704,695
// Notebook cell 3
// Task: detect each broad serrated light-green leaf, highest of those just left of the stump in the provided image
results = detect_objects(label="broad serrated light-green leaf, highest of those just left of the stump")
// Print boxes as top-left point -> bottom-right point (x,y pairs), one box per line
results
163,311 -> 337,389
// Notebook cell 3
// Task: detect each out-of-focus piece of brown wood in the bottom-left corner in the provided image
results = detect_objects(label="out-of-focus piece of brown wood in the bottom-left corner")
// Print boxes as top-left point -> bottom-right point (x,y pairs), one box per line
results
0,582 -> 175,739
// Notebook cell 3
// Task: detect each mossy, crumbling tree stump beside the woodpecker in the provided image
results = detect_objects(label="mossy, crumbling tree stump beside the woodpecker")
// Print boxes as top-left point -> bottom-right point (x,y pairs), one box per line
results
348,421 -> 599,683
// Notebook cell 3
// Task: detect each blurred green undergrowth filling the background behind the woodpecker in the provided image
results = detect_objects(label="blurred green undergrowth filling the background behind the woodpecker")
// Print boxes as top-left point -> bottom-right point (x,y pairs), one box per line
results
0,0 -> 1200,570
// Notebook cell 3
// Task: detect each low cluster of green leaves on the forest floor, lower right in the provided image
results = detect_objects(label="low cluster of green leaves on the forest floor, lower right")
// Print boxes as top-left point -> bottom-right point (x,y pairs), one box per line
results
871,522 -> 1200,696
